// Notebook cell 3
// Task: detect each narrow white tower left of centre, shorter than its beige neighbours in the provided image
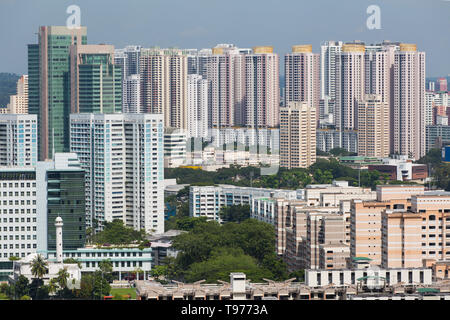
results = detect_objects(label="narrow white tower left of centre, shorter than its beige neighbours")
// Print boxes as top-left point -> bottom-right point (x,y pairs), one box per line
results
187,74 -> 208,139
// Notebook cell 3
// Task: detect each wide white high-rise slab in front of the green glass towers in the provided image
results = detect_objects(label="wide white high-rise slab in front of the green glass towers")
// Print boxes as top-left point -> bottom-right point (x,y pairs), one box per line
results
70,113 -> 164,233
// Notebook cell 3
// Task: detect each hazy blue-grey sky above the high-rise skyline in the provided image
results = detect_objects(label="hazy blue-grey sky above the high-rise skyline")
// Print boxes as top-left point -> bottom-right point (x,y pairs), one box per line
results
0,0 -> 450,77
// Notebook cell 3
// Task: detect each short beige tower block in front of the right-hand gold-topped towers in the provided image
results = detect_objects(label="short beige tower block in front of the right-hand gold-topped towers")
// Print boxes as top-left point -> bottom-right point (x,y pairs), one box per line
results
357,95 -> 390,158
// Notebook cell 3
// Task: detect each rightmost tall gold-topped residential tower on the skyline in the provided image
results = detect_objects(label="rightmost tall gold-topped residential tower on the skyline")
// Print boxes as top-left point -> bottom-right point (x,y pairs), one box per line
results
391,44 -> 426,160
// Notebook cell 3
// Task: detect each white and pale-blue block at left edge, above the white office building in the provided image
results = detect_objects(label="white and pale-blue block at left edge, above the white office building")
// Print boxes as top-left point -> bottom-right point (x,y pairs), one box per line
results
0,114 -> 38,166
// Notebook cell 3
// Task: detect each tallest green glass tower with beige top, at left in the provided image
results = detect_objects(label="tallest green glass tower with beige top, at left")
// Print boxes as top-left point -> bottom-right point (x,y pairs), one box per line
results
28,26 -> 87,161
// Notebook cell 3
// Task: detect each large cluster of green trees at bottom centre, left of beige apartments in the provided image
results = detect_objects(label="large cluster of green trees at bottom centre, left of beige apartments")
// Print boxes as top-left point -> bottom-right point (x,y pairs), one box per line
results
165,218 -> 287,282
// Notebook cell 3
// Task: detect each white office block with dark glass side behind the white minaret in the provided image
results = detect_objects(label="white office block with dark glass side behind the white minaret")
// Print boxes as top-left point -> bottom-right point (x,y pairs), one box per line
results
0,153 -> 86,261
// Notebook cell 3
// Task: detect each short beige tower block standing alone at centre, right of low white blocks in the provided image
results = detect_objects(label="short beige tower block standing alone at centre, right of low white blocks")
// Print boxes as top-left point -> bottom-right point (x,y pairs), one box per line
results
280,102 -> 316,169
